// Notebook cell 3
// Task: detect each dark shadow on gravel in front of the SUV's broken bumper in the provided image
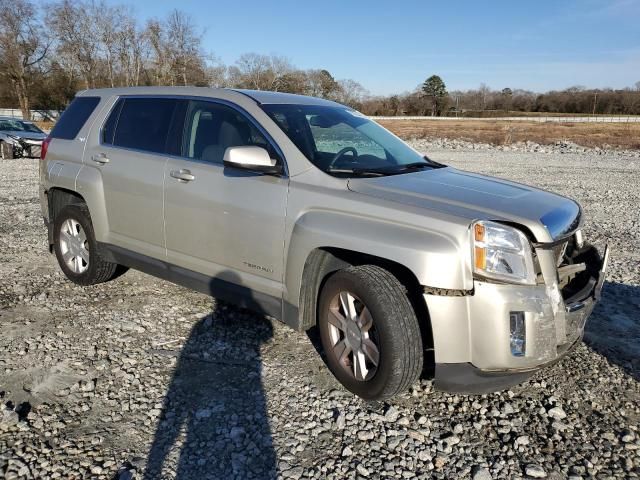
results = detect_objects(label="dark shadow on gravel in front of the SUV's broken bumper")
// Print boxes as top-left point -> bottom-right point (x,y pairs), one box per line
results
584,282 -> 640,381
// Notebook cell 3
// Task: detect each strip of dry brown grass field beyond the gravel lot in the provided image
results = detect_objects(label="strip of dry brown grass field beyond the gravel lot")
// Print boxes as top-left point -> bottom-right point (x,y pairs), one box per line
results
379,119 -> 640,149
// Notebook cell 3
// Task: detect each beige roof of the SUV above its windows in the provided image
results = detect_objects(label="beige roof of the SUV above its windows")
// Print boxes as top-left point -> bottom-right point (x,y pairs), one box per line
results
78,87 -> 342,107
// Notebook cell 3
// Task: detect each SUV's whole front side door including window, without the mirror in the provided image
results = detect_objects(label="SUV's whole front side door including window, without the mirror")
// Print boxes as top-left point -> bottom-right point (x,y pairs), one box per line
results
164,100 -> 288,298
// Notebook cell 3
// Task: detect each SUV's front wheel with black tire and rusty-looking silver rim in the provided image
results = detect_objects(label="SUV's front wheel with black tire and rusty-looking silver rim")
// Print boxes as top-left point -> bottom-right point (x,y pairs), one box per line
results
318,265 -> 424,400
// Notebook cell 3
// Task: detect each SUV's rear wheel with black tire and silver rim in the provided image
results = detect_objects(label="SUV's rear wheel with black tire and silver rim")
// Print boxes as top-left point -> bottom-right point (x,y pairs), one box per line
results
53,204 -> 123,285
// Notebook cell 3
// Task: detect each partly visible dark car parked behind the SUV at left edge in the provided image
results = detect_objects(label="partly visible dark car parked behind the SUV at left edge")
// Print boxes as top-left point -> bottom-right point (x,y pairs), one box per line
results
0,117 -> 47,159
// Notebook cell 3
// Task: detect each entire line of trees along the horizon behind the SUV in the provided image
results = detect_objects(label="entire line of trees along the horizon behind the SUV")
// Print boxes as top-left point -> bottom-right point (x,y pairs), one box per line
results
0,0 -> 640,118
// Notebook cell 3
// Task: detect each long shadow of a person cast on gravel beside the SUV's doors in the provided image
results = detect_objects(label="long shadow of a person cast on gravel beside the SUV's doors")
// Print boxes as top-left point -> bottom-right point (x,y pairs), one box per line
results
143,276 -> 276,480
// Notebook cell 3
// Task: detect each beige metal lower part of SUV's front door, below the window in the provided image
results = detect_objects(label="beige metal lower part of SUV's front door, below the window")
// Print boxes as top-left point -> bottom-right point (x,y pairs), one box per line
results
164,158 -> 288,298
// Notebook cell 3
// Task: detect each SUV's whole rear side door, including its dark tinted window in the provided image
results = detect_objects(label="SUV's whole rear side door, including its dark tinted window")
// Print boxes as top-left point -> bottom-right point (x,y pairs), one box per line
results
84,97 -> 182,259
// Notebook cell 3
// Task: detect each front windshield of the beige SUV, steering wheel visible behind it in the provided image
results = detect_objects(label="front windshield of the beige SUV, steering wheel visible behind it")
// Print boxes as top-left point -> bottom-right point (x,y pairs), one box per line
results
262,105 -> 440,176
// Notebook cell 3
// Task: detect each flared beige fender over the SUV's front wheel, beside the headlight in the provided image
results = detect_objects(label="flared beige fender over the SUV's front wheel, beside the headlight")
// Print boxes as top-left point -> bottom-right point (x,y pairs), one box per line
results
285,210 -> 473,306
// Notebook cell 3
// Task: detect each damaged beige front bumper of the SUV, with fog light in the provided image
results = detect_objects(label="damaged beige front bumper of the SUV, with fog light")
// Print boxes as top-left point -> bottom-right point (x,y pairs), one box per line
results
424,239 -> 609,393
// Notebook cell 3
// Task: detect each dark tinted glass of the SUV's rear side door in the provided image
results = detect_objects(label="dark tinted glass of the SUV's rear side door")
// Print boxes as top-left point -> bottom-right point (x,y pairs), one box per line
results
111,98 -> 181,153
